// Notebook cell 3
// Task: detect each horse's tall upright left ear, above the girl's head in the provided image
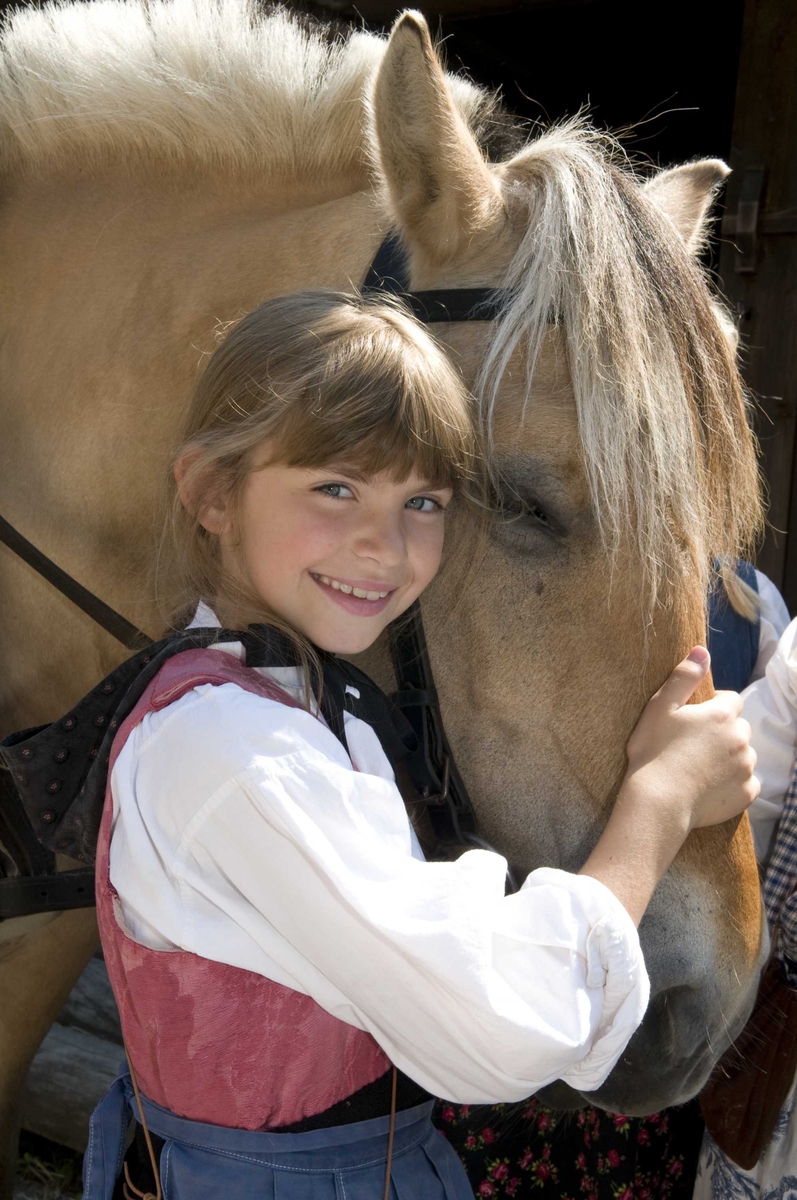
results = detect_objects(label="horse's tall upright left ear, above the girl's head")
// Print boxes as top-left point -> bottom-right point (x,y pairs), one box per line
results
373,12 -> 501,264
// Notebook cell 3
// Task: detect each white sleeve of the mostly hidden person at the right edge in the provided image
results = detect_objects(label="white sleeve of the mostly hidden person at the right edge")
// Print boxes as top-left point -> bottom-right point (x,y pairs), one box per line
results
742,620 -> 797,864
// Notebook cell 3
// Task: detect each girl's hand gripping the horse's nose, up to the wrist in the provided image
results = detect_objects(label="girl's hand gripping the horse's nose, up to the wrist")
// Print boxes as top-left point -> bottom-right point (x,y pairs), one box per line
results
623,646 -> 761,833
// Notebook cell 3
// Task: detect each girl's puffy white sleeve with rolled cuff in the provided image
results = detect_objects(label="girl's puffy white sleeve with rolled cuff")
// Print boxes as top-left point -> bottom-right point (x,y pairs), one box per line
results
112,685 -> 649,1103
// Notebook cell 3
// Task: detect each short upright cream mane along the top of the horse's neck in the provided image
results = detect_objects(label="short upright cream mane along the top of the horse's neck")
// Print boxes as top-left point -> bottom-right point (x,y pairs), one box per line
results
0,0 -> 497,178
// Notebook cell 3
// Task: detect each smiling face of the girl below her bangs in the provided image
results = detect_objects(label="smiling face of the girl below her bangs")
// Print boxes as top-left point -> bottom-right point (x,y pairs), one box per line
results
203,455 -> 451,654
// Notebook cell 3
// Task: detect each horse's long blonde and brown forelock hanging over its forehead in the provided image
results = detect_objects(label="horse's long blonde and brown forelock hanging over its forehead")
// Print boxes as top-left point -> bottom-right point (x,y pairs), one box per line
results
479,119 -> 763,614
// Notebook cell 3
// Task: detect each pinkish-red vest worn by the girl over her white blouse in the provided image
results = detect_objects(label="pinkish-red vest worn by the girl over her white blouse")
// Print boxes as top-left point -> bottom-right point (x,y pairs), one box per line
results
96,650 -> 390,1129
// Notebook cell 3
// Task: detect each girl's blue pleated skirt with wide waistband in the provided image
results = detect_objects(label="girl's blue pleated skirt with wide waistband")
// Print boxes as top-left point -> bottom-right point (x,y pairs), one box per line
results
83,1072 -> 473,1200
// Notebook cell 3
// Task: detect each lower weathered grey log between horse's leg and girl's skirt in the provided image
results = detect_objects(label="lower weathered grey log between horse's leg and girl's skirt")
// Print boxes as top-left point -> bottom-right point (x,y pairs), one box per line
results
22,1025 -> 124,1151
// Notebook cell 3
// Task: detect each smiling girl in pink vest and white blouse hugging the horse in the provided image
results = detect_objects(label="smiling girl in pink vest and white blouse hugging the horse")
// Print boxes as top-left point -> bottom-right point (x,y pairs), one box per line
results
85,293 -> 757,1200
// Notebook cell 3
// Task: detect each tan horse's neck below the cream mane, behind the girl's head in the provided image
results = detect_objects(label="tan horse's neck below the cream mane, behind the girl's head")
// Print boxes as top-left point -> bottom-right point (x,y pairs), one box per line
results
0,180 -> 380,728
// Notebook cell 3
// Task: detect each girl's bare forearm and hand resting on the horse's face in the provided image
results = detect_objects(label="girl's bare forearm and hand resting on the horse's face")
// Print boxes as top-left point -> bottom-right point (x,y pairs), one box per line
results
581,646 -> 760,924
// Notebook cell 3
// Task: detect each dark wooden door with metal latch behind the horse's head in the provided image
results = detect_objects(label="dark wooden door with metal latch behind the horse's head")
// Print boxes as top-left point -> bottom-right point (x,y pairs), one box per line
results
720,0 -> 797,612
